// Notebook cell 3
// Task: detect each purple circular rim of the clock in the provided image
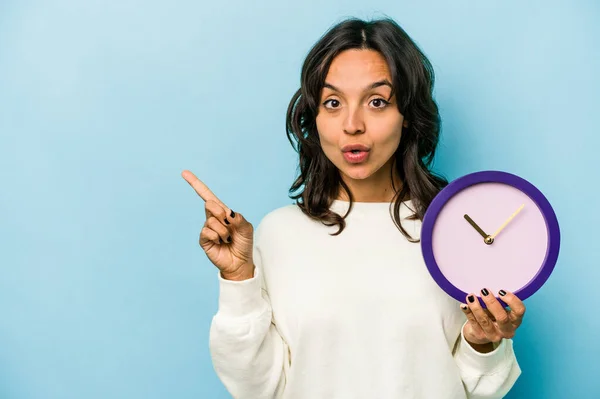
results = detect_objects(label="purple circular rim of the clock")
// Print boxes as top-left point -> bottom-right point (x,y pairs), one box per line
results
421,170 -> 560,307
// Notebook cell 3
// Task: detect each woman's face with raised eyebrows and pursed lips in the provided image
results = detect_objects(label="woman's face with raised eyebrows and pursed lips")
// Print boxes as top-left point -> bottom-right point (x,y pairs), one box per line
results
316,50 -> 407,191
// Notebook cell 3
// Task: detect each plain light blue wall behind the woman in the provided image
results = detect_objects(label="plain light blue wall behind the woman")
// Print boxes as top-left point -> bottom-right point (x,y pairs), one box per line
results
0,0 -> 600,399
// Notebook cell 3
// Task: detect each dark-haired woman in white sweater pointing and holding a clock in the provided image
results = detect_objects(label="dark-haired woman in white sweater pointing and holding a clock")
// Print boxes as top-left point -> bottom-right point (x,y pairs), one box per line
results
182,19 -> 525,399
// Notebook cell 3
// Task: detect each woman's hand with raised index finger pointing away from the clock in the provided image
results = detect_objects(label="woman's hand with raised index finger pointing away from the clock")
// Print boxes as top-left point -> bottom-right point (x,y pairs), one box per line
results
181,170 -> 254,280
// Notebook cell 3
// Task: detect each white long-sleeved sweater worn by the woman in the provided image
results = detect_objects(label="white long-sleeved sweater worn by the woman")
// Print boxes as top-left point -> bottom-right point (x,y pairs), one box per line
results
210,200 -> 521,399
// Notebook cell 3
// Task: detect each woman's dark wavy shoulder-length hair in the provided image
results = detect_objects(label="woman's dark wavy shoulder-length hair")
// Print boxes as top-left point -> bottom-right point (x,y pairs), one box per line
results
286,18 -> 448,242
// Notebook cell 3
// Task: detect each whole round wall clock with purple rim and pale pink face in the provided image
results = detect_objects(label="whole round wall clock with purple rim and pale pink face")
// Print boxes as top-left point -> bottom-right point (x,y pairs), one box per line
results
421,171 -> 560,305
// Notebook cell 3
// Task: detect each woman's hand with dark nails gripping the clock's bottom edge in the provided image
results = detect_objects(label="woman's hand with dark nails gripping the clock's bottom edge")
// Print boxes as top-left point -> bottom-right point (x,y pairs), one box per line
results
460,289 -> 525,345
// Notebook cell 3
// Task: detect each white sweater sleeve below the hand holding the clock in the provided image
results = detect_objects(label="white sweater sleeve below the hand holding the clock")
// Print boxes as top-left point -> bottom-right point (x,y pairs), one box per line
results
454,322 -> 521,399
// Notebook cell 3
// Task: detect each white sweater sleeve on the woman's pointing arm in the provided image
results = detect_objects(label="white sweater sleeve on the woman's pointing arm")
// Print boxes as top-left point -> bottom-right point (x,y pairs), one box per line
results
209,233 -> 290,399
